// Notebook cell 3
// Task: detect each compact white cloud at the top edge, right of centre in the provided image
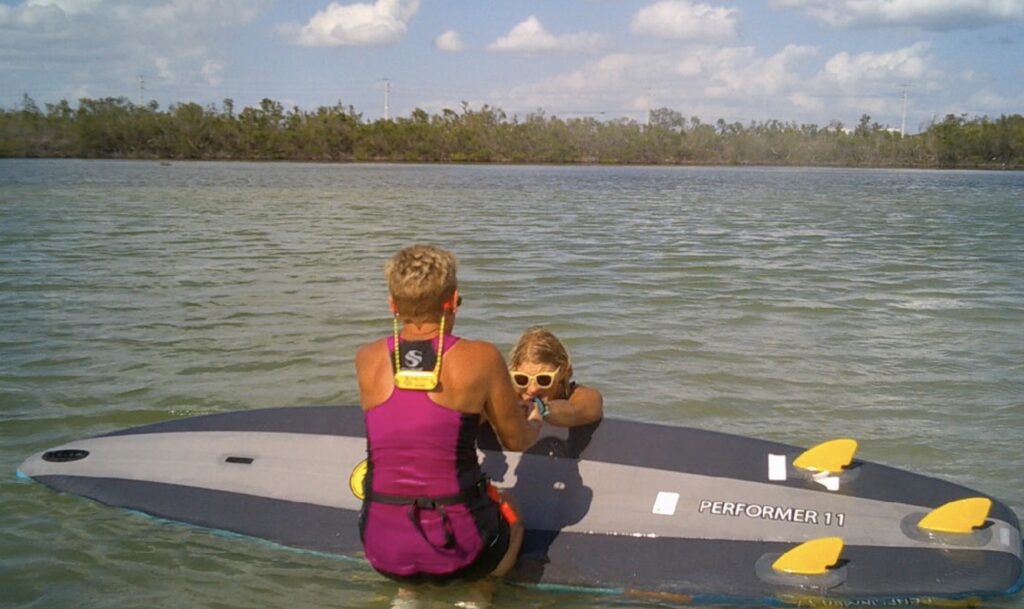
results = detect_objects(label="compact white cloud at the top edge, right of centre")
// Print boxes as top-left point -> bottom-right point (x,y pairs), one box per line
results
631,0 -> 739,41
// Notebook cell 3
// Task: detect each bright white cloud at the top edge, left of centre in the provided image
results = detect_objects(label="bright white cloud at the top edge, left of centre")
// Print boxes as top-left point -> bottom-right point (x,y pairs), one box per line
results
295,0 -> 420,46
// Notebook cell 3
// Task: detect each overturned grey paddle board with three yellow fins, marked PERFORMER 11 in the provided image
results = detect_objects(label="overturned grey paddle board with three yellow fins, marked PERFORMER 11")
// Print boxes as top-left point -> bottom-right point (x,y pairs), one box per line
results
19,406 -> 1022,606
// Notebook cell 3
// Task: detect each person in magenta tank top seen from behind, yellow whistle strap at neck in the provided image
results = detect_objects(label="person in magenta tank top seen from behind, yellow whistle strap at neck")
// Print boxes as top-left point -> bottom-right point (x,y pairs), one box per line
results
355,246 -> 542,582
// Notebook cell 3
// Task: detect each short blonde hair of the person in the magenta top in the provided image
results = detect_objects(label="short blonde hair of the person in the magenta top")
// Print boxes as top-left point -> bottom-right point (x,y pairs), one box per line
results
384,245 -> 459,323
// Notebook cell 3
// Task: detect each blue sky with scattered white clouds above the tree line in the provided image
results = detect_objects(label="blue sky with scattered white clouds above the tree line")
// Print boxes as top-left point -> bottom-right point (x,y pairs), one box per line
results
0,0 -> 1024,133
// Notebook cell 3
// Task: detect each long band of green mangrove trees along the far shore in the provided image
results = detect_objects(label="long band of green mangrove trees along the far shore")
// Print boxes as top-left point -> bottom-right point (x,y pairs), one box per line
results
0,96 -> 1024,169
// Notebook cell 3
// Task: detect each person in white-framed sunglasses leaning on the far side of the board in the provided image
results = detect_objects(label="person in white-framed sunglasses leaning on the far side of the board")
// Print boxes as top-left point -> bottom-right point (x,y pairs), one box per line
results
509,325 -> 604,427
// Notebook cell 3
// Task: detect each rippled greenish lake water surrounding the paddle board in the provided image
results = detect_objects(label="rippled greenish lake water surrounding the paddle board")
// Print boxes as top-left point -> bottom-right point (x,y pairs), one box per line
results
0,160 -> 1024,609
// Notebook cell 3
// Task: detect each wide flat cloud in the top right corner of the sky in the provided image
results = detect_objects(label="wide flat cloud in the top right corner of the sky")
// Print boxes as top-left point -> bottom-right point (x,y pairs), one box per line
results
773,0 -> 1024,32
